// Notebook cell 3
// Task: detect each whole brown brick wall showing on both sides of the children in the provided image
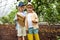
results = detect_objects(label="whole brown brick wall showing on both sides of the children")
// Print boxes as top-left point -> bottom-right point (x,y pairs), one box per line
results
0,24 -> 60,40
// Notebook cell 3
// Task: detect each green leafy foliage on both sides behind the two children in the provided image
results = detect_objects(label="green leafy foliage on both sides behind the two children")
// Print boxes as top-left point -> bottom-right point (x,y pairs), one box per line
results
0,0 -> 60,24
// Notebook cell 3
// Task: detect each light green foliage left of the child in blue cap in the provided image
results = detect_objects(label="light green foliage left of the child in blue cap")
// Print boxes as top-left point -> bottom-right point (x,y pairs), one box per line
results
0,9 -> 17,24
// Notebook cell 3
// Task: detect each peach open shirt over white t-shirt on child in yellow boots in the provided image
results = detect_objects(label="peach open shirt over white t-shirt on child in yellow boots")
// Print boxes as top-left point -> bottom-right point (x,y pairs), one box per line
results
25,12 -> 38,29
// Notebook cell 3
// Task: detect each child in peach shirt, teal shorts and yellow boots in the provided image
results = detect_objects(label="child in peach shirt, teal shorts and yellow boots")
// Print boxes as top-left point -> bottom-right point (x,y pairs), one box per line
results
25,3 -> 40,40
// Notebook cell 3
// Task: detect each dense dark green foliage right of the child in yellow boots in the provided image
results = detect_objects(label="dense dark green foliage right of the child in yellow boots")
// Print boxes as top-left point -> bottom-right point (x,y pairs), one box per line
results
32,0 -> 60,24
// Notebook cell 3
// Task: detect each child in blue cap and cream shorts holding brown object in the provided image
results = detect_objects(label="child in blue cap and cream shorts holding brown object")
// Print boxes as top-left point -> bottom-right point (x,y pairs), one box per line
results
15,2 -> 26,40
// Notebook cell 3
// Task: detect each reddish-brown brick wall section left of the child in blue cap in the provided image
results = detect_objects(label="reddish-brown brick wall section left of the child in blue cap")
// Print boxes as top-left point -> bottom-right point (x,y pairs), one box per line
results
0,25 -> 17,40
